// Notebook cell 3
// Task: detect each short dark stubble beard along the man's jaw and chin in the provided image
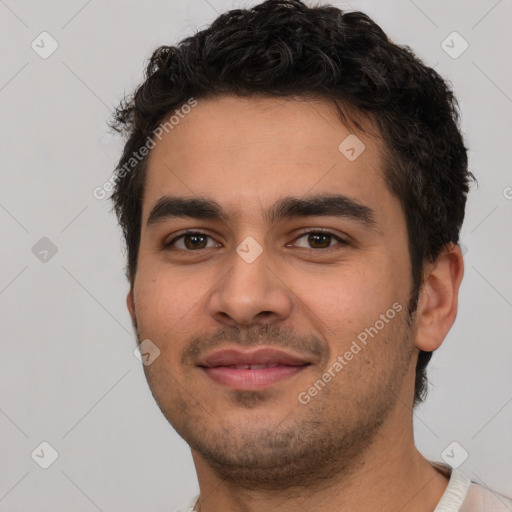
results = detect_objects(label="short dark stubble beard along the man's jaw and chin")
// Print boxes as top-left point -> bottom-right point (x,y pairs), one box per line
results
137,315 -> 414,491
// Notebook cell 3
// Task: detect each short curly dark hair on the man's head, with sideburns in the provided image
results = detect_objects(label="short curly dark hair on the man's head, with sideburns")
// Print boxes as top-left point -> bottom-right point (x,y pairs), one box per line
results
110,0 -> 474,405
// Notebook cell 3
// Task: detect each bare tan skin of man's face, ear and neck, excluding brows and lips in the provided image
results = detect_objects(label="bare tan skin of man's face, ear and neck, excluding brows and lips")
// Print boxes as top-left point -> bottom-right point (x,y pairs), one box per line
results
127,96 -> 463,512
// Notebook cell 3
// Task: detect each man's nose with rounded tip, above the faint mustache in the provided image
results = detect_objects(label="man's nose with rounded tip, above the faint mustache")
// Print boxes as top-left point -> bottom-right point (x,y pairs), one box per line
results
208,242 -> 293,326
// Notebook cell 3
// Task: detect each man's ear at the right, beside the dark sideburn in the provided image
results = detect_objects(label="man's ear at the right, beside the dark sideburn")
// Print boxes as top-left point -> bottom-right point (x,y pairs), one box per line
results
416,242 -> 464,352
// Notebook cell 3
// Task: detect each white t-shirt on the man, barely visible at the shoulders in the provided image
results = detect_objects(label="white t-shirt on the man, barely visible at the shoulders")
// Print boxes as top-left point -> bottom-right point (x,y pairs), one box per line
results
176,462 -> 512,512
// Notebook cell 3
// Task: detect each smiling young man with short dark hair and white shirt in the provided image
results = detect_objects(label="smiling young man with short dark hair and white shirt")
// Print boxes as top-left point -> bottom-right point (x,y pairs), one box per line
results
112,0 -> 512,512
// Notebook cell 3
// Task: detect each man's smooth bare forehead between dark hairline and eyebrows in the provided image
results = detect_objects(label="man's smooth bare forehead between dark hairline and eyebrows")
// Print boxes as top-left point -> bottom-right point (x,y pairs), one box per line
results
143,96 -> 392,224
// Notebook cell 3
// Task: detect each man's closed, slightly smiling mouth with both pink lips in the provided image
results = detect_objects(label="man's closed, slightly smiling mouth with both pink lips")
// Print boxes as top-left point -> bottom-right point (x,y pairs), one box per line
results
198,348 -> 312,390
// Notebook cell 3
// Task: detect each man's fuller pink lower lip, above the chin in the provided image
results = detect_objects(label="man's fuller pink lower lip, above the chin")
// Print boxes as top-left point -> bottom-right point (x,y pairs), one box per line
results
203,365 -> 307,389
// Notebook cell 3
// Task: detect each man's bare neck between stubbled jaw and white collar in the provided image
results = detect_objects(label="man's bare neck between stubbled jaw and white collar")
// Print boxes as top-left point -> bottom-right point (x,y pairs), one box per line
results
192,402 -> 448,512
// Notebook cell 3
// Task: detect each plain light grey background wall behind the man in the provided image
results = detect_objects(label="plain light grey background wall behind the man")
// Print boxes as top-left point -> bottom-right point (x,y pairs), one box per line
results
0,0 -> 512,512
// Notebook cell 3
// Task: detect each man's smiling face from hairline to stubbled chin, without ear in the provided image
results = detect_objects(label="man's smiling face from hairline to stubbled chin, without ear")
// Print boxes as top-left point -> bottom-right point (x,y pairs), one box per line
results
128,97 -> 415,487
